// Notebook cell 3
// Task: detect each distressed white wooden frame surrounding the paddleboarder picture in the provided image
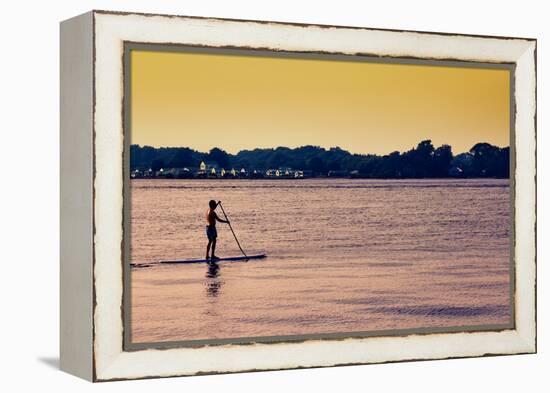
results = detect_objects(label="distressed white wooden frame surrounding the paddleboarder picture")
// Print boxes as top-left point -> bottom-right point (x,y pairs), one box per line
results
60,11 -> 536,381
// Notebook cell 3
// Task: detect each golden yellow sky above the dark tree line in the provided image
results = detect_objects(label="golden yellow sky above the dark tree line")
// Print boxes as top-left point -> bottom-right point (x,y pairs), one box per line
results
131,49 -> 510,154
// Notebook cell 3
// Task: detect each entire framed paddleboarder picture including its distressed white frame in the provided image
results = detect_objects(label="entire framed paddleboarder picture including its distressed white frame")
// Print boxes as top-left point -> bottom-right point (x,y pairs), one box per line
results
60,11 -> 536,381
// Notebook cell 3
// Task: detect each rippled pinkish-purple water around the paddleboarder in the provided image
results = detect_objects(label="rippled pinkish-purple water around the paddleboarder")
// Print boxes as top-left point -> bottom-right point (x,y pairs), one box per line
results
131,179 -> 511,342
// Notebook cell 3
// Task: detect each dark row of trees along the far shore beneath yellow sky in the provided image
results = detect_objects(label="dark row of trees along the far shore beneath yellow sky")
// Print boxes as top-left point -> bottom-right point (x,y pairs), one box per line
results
130,140 -> 510,178
